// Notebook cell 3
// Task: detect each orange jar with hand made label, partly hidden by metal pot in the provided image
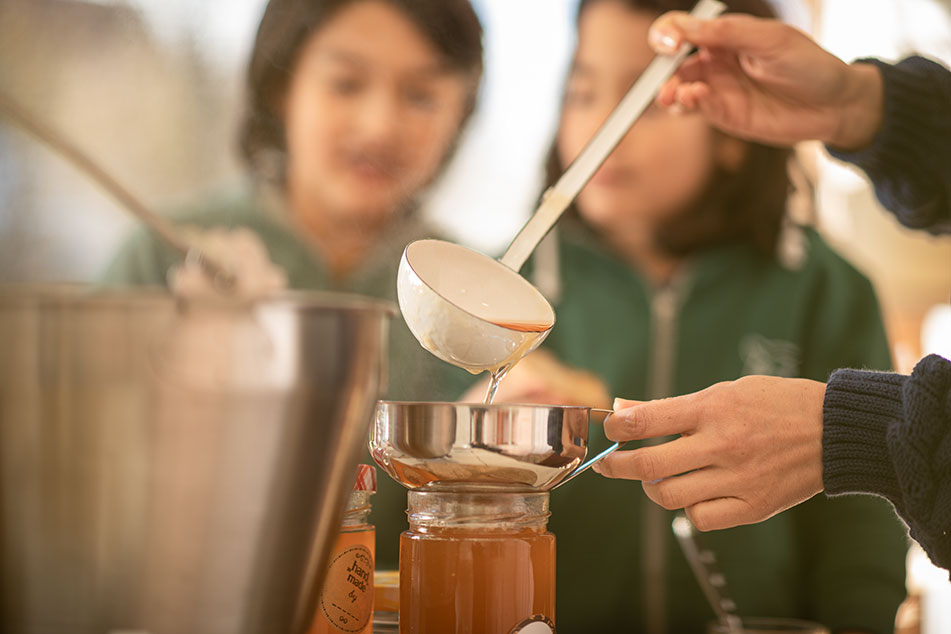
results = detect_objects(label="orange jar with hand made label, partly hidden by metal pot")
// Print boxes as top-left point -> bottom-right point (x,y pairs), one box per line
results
310,465 -> 376,634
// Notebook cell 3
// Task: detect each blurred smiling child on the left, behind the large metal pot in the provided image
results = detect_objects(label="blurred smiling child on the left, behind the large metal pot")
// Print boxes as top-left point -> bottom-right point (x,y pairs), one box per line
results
102,0 -> 482,568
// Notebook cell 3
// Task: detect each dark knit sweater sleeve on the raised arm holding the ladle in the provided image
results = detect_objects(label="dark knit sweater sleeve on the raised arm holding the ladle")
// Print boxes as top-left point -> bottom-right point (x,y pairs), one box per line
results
829,56 -> 951,234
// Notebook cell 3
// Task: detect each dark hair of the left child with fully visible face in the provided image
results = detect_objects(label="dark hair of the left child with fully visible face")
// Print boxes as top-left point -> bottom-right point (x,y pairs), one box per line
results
240,0 -> 482,178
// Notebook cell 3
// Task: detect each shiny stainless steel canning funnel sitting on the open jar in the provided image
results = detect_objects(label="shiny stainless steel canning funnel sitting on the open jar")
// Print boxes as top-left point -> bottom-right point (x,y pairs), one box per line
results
370,401 -> 618,491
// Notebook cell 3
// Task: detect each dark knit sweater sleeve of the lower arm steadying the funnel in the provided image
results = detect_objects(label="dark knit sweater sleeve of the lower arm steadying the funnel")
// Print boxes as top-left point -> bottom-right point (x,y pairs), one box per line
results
822,355 -> 951,569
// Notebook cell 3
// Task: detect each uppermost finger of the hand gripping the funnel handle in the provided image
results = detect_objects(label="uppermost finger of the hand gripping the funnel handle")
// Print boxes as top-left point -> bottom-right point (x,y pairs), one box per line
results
604,394 -> 701,442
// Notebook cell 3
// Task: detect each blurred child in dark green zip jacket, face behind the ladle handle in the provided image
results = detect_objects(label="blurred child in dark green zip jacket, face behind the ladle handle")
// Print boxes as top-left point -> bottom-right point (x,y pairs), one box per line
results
488,0 -> 906,634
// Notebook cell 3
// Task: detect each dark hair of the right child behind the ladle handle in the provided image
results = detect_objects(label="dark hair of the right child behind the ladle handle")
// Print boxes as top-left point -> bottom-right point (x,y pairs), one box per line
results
546,0 -> 791,257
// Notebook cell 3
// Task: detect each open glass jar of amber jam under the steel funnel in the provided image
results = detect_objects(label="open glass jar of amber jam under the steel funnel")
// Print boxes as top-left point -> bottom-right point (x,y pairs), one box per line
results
400,485 -> 555,634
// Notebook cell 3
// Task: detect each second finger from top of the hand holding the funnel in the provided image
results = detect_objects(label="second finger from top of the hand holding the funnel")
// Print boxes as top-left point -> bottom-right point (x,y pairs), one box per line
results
595,436 -> 711,482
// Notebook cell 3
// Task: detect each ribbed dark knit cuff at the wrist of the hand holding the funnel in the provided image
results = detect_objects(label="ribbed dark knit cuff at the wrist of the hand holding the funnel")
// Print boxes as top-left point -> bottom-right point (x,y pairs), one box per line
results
822,370 -> 907,508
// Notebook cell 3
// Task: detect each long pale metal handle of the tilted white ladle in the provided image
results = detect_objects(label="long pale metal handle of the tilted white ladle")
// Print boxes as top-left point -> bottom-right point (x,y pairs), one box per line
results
499,0 -> 726,271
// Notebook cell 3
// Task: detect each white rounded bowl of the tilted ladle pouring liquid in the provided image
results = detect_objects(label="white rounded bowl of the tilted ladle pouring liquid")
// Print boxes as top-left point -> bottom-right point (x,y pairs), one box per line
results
397,240 -> 555,373
